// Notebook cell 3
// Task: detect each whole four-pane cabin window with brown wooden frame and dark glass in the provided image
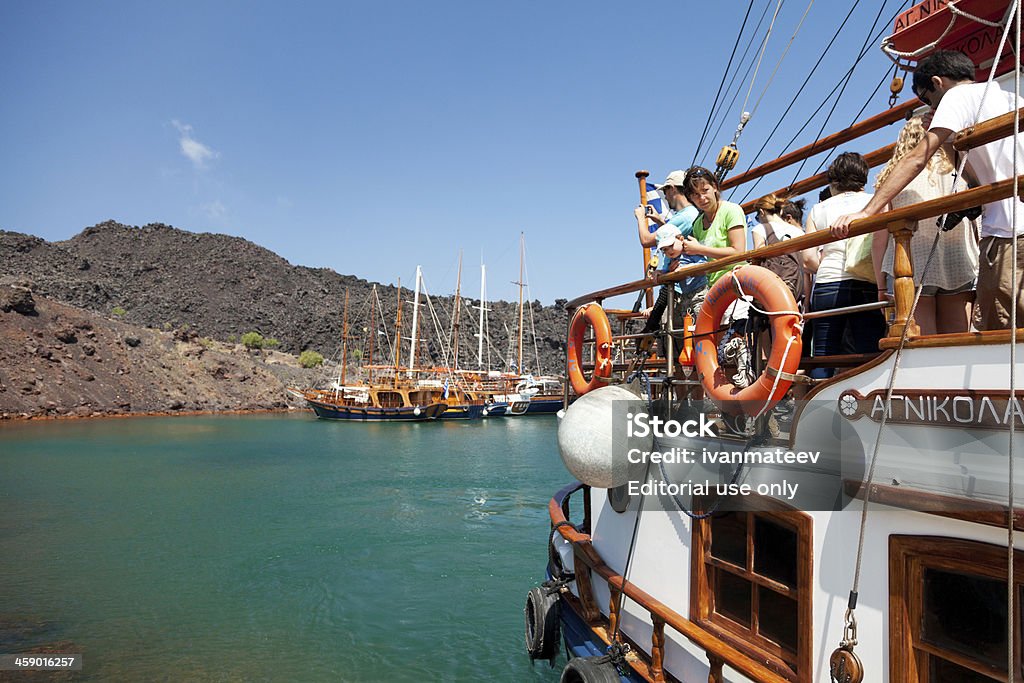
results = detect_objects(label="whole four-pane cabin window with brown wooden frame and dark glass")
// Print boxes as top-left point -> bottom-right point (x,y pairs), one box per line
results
691,509 -> 812,681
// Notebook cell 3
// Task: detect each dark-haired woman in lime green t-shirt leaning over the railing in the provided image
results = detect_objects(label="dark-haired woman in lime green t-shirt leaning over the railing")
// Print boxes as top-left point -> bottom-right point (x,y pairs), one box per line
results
683,166 -> 746,286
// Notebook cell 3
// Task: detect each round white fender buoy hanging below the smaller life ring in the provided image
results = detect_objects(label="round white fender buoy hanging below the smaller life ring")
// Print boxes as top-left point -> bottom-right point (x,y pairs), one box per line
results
558,384 -> 652,488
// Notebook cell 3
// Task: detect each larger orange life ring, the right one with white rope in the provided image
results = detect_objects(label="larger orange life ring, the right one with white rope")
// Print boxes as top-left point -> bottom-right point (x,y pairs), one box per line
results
694,265 -> 803,415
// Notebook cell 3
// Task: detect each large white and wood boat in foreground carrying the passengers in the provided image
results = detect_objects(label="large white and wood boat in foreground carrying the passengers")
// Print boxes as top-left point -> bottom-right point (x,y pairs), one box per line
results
525,2 -> 1024,683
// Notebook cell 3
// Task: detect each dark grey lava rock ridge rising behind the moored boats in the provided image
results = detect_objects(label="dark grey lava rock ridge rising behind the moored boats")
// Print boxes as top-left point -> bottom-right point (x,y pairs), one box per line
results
0,221 -> 565,373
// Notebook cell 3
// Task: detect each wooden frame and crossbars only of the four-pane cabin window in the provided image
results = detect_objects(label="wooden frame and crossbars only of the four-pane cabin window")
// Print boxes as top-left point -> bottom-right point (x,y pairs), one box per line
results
690,499 -> 814,683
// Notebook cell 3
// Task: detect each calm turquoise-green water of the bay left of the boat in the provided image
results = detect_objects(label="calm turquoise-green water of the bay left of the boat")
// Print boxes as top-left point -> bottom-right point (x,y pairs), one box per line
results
0,415 -> 570,681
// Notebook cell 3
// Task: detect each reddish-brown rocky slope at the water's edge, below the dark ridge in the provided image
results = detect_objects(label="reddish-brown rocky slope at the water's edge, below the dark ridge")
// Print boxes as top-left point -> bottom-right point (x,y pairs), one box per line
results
0,281 -> 323,420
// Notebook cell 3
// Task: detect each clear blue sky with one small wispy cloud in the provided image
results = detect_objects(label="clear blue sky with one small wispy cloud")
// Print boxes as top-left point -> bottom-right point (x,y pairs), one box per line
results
0,0 -> 908,303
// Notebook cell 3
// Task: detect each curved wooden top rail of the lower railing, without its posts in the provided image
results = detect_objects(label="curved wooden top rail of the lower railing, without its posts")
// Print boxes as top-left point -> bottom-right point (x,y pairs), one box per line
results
548,482 -> 790,683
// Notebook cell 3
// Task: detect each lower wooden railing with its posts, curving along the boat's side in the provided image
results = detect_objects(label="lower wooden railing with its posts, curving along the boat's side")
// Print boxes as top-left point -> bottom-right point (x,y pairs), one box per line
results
548,481 -> 790,683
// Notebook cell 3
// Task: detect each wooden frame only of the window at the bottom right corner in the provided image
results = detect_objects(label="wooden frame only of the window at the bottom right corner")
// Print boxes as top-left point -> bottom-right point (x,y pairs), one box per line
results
889,535 -> 1024,683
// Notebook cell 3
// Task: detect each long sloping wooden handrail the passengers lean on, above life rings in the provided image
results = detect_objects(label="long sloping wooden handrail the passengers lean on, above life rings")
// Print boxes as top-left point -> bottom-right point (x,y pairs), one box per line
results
565,176 -> 1024,311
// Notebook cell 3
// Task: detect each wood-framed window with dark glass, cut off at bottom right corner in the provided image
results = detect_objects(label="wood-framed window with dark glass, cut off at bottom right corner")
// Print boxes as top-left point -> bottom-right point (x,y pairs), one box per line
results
889,536 -> 1024,683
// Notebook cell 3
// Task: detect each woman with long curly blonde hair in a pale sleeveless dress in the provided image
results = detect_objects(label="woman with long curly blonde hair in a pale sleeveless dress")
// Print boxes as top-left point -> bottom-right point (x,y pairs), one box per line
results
871,117 -> 978,335
